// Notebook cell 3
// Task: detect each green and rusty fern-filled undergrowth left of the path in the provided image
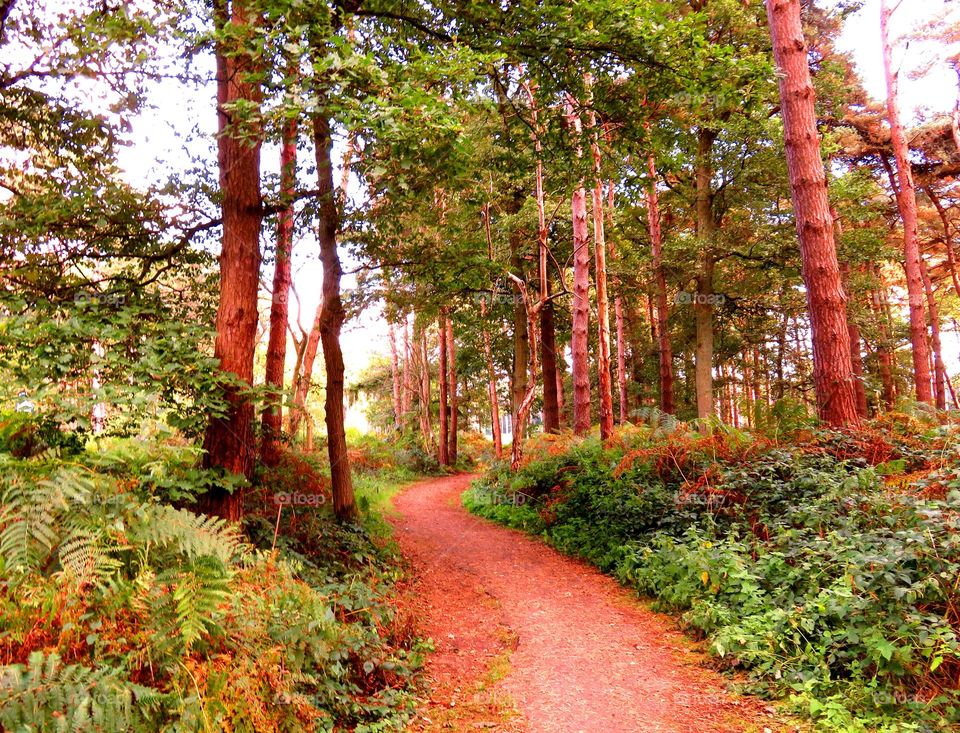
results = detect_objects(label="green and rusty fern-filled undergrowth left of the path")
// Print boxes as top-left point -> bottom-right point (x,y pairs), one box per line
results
0,436 -> 422,733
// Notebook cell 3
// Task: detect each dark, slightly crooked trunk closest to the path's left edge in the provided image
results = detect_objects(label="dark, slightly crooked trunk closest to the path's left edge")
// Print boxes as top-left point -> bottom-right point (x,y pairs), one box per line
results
313,114 -> 357,522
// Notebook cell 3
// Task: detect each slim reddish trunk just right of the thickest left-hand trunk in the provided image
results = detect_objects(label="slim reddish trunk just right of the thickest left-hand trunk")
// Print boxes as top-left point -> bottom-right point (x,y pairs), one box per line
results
260,120 -> 297,466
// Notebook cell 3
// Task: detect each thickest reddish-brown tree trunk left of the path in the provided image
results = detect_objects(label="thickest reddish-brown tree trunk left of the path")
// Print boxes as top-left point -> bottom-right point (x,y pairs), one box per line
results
200,0 -> 263,520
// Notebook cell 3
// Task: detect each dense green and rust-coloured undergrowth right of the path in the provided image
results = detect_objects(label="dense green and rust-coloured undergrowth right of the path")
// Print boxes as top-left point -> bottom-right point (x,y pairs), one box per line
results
464,415 -> 960,732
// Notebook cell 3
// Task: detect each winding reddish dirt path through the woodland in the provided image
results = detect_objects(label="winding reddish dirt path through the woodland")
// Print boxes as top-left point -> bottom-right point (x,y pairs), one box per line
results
391,475 -> 792,733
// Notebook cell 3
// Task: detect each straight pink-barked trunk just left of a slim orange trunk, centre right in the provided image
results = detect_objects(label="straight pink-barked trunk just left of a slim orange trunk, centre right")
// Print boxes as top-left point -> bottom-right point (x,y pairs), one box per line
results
566,93 -> 590,435
